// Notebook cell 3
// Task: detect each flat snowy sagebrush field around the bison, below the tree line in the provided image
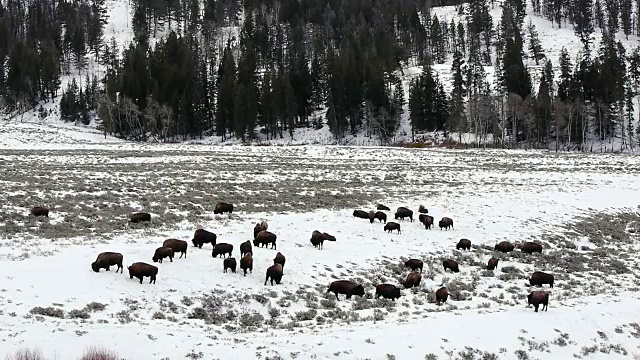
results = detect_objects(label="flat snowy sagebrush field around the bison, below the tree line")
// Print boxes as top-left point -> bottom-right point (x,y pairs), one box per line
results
0,143 -> 640,359
